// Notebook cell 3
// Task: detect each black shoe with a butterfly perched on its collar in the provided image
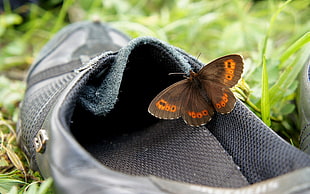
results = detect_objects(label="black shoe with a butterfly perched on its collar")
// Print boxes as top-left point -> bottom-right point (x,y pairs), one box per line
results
17,22 -> 310,193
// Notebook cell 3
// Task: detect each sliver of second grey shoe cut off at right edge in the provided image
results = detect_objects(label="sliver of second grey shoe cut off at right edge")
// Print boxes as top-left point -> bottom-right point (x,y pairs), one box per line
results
297,57 -> 310,154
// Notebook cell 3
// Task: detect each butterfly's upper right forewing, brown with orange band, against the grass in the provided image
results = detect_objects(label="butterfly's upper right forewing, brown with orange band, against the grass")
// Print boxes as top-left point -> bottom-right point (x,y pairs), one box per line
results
198,54 -> 243,87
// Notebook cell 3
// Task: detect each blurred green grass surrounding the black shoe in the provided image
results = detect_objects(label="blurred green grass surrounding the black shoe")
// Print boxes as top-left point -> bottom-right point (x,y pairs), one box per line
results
0,0 -> 310,194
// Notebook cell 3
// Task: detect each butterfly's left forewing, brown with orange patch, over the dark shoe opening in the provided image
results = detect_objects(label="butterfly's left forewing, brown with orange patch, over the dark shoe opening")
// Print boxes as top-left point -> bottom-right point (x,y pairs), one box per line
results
148,80 -> 188,119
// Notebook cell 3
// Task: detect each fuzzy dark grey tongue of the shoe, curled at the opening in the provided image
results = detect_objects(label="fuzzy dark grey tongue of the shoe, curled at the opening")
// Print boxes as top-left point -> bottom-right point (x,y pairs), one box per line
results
80,37 -> 202,116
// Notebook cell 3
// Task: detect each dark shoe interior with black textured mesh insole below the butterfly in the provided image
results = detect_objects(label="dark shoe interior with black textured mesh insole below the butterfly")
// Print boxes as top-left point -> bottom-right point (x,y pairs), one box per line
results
71,45 -> 249,187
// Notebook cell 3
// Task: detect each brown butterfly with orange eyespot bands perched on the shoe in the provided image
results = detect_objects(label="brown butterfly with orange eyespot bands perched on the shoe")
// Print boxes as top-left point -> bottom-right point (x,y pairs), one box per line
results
148,54 -> 243,126
